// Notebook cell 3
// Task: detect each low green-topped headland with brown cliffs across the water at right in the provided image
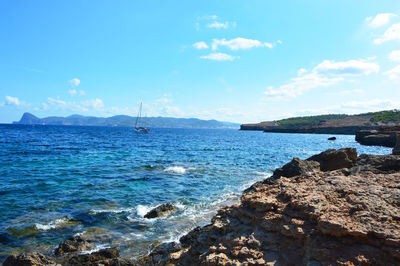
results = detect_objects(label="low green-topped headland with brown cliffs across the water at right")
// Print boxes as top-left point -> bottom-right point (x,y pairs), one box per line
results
240,110 -> 400,135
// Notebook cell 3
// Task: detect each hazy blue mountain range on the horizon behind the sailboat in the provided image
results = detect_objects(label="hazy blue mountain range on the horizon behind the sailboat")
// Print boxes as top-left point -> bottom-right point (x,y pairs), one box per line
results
13,113 -> 240,129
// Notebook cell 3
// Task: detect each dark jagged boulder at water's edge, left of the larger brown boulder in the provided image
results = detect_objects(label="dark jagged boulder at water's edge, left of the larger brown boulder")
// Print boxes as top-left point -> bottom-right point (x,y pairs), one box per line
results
272,157 -> 319,179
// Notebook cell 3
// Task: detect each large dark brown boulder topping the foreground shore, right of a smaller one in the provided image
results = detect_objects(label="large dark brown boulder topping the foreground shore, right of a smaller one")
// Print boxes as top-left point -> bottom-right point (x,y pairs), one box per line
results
307,148 -> 357,172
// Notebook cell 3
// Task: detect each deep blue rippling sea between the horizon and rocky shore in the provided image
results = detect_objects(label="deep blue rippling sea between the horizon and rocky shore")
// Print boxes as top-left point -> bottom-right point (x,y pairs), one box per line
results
0,125 -> 391,261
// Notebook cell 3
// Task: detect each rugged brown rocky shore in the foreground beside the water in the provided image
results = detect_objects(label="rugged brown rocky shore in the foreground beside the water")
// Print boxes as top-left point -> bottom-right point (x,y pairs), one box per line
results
4,149 -> 400,266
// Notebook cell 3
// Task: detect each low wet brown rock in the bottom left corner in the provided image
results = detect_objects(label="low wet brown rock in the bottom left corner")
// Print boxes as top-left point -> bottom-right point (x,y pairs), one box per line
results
3,252 -> 56,266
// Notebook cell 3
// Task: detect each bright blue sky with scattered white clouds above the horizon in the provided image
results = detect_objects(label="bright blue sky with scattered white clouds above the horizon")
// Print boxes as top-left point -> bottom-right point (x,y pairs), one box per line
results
0,0 -> 400,123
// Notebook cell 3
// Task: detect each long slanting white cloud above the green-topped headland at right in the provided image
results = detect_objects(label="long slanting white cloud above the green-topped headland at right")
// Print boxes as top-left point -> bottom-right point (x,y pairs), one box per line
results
264,59 -> 379,100
